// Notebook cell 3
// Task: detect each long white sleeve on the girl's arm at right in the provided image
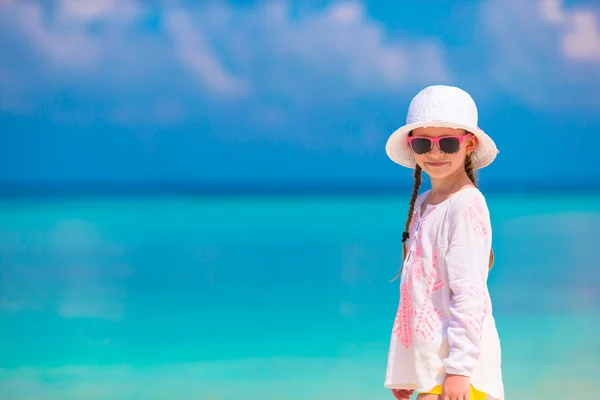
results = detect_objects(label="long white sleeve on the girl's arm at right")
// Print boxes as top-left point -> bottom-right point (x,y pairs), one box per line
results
444,194 -> 491,376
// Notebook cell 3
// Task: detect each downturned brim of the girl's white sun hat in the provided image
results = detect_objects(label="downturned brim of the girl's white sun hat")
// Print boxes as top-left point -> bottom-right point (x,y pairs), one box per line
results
385,121 -> 499,169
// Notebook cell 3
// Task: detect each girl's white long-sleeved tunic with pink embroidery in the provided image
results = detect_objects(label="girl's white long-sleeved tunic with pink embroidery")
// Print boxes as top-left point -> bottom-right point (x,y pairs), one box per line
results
384,188 -> 504,400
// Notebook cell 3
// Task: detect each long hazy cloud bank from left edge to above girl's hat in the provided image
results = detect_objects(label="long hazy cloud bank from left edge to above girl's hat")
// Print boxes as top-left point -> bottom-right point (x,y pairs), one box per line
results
0,0 -> 449,124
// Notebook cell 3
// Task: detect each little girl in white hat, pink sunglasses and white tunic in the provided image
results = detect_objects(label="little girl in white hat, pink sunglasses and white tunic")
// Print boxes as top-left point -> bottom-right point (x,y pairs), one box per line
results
384,85 -> 504,400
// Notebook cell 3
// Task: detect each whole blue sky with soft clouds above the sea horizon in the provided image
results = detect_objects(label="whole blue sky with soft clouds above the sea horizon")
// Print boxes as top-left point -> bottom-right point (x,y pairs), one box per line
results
0,0 -> 600,186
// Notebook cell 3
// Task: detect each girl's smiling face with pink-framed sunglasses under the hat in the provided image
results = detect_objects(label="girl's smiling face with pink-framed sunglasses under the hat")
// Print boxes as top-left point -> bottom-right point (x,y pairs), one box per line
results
408,127 -> 478,179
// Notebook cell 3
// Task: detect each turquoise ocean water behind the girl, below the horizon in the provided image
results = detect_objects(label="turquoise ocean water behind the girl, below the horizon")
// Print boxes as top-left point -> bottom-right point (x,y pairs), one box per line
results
0,193 -> 600,400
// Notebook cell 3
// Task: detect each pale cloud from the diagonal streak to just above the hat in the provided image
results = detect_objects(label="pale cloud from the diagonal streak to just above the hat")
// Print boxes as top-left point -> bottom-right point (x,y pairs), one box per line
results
166,1 -> 448,101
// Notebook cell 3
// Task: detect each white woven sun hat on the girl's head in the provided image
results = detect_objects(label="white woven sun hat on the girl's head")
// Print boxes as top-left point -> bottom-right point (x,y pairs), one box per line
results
385,85 -> 499,169
